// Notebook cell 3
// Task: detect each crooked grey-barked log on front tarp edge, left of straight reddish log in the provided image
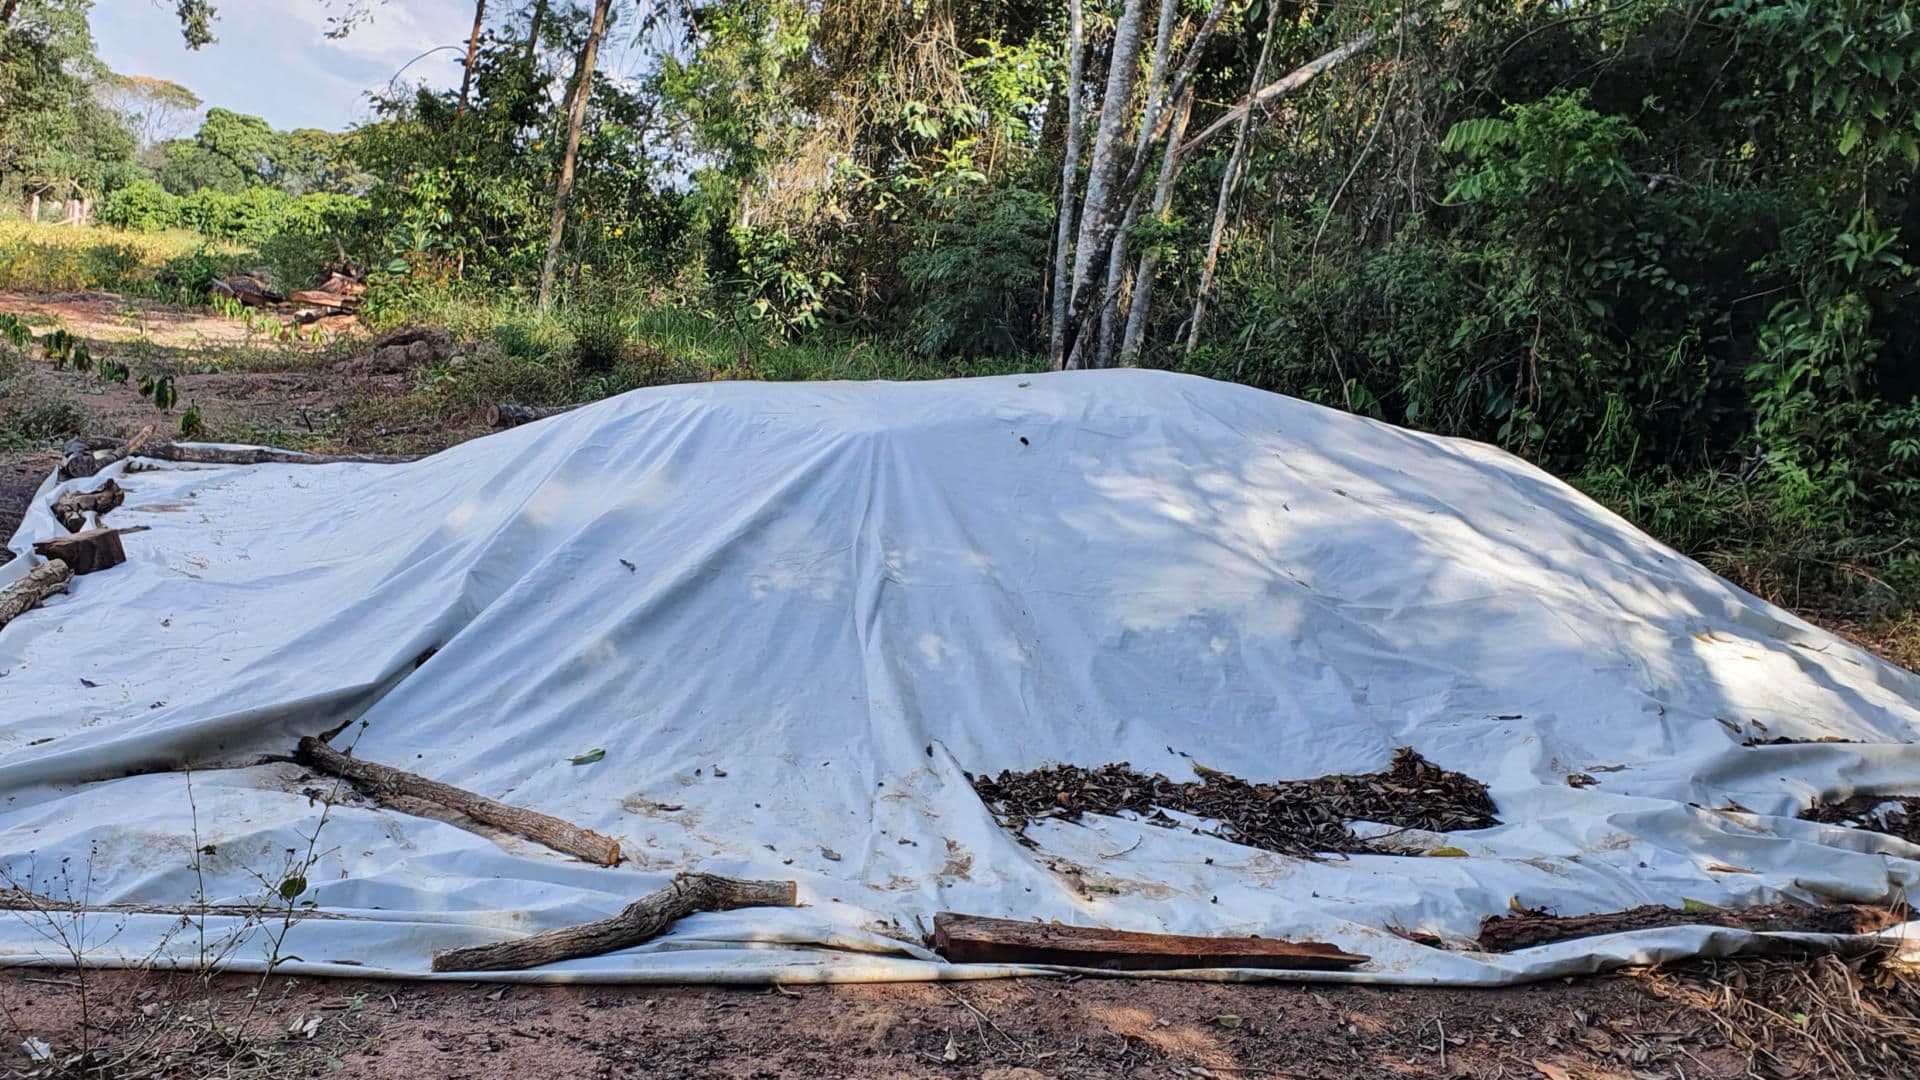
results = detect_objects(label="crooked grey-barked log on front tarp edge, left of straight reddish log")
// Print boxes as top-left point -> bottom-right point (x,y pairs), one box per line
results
434,874 -> 799,970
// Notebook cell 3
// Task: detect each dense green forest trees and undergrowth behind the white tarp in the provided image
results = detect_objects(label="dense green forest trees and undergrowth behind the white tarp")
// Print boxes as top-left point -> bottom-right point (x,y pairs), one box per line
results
0,0 -> 1920,607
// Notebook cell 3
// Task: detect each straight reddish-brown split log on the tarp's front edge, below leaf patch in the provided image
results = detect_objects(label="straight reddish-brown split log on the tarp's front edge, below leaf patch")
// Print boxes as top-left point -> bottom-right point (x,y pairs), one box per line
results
933,911 -> 1371,970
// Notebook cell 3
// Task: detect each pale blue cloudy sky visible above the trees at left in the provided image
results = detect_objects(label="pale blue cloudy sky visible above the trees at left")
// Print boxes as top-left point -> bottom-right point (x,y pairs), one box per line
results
92,0 -> 472,131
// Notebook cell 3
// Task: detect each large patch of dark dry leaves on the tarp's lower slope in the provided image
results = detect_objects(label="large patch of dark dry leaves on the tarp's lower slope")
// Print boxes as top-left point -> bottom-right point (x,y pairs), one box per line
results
972,749 -> 1500,859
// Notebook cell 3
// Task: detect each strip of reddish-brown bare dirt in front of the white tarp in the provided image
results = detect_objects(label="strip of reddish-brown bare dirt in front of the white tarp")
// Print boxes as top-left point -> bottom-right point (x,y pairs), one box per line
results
0,961 -> 1920,1080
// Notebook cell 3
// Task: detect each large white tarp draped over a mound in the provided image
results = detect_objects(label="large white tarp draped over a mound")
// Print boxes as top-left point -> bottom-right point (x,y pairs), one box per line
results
0,371 -> 1920,984
